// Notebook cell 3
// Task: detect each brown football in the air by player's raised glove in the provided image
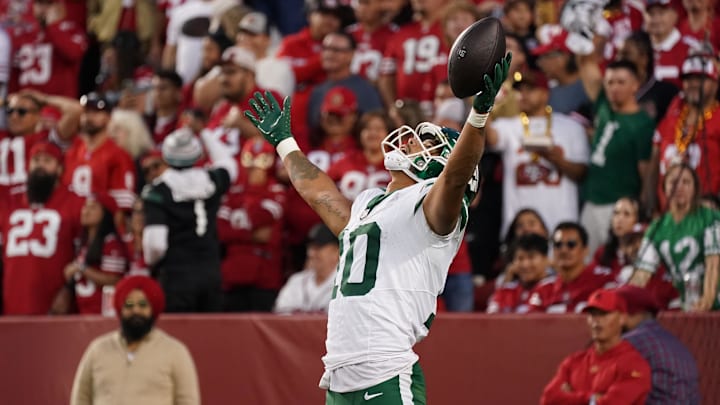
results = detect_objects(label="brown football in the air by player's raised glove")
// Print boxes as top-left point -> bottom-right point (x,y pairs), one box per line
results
448,17 -> 505,98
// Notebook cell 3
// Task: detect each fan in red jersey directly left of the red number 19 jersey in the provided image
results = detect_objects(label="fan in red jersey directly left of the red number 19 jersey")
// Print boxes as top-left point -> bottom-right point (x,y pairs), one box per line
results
345,0 -> 398,83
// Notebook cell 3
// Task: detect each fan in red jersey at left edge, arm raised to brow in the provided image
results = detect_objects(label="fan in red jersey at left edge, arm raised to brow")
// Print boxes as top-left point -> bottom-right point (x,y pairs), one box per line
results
0,90 -> 82,197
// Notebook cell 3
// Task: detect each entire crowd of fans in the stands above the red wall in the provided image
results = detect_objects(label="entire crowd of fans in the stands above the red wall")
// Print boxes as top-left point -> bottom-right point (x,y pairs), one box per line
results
0,0 -> 720,315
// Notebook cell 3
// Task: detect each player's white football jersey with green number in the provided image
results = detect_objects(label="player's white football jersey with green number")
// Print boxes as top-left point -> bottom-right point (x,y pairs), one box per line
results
320,179 -> 467,392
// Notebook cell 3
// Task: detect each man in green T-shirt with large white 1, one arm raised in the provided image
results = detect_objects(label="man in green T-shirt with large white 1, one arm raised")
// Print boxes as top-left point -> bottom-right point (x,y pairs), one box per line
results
578,56 -> 655,254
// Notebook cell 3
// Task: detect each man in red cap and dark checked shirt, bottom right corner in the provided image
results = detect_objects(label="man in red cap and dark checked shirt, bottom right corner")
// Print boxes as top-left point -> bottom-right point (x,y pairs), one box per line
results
616,285 -> 700,405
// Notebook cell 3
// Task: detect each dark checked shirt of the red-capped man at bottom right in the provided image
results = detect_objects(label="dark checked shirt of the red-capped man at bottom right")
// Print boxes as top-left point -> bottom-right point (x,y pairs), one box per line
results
623,319 -> 700,405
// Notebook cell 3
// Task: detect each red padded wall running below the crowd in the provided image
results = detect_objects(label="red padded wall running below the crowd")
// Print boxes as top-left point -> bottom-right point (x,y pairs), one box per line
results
0,314 -> 720,405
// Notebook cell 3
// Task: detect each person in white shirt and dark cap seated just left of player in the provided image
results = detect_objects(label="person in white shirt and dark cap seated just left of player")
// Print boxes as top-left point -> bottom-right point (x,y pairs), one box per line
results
274,223 -> 340,314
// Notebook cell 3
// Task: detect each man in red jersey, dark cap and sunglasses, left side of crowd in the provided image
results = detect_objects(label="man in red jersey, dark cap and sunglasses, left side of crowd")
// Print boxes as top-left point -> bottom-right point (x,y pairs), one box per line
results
63,93 -> 135,210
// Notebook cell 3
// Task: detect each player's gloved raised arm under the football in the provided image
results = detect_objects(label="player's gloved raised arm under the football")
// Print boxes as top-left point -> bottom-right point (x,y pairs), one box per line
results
423,53 -> 512,235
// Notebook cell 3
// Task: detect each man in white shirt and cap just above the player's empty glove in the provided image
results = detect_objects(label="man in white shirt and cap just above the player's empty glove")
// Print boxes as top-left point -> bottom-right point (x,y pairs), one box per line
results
236,12 -> 295,97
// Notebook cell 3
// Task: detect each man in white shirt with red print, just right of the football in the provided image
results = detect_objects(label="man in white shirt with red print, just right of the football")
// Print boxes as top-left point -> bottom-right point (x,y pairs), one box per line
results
487,71 -> 590,235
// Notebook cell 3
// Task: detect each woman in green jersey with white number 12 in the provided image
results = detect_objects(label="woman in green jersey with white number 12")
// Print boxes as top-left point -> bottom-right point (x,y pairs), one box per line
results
630,163 -> 720,311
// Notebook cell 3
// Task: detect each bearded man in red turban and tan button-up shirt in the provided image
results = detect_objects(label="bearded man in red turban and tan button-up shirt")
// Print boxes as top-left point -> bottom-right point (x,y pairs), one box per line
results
70,276 -> 200,405
